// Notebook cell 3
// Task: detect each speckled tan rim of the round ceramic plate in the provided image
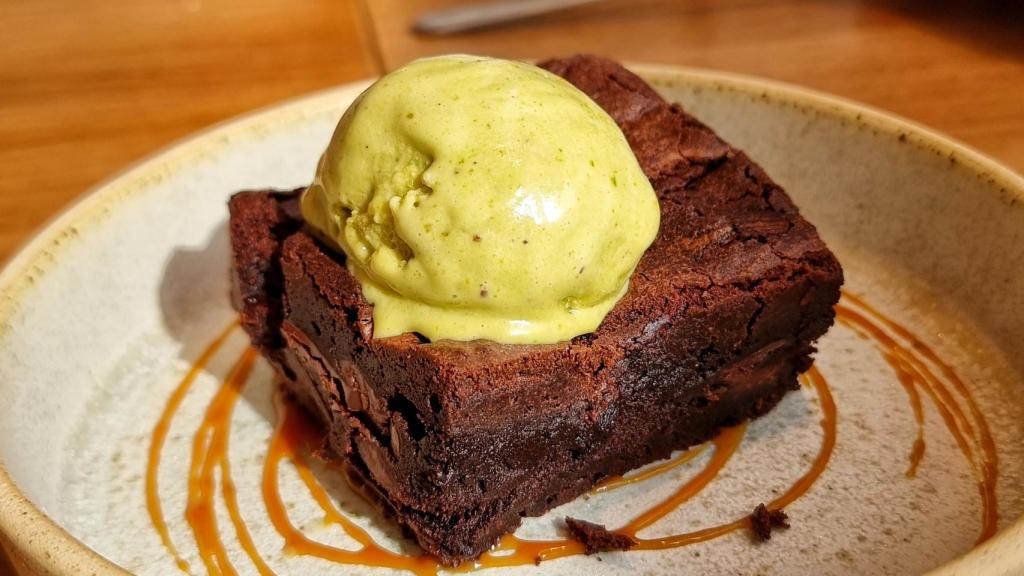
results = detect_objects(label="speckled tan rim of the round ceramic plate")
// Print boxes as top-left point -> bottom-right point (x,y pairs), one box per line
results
0,64 -> 1024,576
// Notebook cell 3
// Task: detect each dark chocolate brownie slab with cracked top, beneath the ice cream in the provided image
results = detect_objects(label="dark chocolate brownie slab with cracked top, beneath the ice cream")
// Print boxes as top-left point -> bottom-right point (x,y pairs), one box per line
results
230,51 -> 843,565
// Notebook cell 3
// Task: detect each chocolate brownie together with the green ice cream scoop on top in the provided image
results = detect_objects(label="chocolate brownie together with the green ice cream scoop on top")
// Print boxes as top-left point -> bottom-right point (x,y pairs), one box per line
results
229,51 -> 843,565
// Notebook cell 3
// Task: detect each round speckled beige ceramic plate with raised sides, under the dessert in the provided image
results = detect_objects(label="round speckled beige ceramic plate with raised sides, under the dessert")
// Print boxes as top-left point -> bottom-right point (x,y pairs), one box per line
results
0,66 -> 1024,575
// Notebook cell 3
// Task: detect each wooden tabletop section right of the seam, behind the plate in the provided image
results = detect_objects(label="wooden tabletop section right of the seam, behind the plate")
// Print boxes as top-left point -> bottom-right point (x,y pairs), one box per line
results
369,0 -> 1024,171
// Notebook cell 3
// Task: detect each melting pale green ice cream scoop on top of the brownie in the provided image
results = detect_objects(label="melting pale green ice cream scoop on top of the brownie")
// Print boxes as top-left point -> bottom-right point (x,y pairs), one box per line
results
302,55 -> 659,343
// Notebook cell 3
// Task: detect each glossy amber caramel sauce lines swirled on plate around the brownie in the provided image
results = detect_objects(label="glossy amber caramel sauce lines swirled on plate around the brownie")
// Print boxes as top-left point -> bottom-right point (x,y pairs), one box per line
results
146,293 -> 997,576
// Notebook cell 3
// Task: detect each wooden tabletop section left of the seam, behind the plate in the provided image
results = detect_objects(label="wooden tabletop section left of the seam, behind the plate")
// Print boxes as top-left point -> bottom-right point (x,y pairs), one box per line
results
0,0 -> 378,261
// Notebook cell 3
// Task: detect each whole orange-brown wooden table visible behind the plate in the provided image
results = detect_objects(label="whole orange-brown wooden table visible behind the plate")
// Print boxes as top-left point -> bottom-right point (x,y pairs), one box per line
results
0,0 -> 1024,567
